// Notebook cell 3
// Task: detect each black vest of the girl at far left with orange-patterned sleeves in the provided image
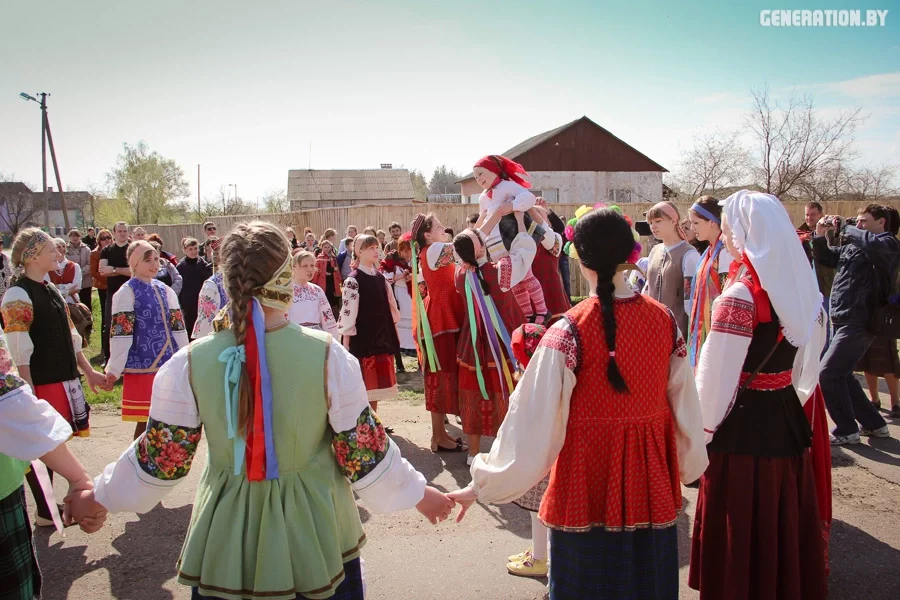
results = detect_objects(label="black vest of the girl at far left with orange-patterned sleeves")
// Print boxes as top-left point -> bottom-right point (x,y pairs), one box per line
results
16,277 -> 78,385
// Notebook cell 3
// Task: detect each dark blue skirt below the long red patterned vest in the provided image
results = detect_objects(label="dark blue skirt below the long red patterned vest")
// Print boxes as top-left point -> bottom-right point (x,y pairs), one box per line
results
550,526 -> 678,600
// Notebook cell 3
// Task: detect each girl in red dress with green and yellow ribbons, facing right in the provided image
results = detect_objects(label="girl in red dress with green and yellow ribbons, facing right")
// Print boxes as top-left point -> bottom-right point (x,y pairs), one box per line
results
410,214 -> 466,452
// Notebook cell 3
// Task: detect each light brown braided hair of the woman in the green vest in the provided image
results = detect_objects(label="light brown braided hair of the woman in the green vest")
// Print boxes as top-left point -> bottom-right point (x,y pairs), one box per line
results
220,221 -> 291,431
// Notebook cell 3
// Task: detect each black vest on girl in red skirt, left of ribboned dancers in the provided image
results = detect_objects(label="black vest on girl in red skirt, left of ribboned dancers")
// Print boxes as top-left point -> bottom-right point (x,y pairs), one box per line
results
350,269 -> 400,358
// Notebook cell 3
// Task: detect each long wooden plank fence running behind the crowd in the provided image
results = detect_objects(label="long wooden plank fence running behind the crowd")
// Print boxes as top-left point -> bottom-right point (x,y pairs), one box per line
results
137,202 -> 900,296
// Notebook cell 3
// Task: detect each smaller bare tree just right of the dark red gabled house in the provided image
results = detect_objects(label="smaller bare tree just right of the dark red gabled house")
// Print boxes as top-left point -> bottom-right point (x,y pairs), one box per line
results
670,131 -> 750,198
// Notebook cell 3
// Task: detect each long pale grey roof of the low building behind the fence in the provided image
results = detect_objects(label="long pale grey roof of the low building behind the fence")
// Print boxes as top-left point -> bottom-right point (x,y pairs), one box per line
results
287,169 -> 416,202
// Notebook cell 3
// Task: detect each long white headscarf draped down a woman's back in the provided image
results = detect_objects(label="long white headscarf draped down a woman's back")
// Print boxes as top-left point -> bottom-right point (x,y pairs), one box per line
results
719,190 -> 822,348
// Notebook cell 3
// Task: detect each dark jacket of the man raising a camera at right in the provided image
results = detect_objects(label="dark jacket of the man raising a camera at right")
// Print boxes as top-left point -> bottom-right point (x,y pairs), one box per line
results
813,226 -> 900,327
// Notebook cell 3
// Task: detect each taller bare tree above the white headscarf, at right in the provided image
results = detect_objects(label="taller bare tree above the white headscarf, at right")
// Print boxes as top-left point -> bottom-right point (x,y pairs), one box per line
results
747,87 -> 862,197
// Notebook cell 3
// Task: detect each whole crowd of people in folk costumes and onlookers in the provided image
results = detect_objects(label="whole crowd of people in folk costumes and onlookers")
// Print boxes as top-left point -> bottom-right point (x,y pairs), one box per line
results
0,156 -> 900,600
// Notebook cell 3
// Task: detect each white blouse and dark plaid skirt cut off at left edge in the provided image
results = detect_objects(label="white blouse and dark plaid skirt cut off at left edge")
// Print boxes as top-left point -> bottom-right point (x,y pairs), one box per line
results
0,335 -> 72,600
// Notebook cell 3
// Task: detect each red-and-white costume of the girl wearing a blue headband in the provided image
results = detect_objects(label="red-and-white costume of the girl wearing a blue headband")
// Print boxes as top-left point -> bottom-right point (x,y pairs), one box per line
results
687,235 -> 734,369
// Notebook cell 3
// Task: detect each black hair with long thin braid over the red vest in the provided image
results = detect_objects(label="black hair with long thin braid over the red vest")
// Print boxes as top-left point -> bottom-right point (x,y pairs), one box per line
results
574,209 -> 634,392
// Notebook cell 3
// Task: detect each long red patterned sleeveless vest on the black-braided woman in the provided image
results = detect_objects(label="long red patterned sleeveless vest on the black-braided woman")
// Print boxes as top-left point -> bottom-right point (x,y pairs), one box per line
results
540,296 -> 685,531
